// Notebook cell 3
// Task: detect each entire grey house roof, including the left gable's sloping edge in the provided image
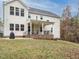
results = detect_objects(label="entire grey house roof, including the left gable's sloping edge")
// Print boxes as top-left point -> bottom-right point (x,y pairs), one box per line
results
5,0 -> 60,18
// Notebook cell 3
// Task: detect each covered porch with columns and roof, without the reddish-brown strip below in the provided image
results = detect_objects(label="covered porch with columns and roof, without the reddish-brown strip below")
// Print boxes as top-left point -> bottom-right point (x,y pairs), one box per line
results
28,20 -> 54,35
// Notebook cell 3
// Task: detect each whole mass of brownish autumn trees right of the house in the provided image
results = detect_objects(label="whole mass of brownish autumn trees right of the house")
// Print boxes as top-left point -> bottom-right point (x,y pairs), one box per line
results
61,7 -> 79,42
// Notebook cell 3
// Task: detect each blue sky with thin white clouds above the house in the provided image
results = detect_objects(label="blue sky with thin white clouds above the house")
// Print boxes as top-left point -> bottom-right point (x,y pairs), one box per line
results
0,0 -> 79,17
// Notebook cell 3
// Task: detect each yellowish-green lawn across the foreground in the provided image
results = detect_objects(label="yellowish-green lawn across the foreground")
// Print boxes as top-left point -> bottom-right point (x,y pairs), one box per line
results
0,40 -> 79,59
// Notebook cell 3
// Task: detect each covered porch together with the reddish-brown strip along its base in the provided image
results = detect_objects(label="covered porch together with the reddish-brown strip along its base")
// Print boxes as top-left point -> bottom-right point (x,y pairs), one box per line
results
26,20 -> 54,38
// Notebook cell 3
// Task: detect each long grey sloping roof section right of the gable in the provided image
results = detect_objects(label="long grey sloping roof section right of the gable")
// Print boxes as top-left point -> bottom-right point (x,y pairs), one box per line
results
29,7 -> 60,18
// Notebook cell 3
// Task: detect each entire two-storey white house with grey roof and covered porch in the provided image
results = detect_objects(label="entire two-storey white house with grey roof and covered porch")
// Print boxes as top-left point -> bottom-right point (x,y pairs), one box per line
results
3,0 -> 60,38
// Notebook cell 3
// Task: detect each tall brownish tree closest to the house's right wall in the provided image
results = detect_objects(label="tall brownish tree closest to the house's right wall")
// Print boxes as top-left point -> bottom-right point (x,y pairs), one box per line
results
61,5 -> 71,40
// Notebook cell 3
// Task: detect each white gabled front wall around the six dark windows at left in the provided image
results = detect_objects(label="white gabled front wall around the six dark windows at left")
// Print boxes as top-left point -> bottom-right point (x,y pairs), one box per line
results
4,1 -> 28,36
